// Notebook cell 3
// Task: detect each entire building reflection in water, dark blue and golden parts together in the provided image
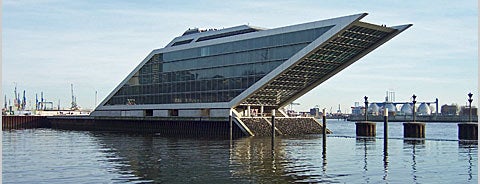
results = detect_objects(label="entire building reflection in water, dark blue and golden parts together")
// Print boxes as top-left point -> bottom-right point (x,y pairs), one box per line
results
92,132 -> 315,183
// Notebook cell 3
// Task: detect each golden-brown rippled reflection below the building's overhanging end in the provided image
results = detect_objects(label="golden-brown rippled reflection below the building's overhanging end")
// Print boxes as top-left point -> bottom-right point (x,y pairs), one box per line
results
230,137 -> 326,183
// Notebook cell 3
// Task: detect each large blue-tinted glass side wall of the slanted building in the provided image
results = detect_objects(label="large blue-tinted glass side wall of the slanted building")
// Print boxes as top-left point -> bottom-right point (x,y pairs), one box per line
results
105,26 -> 333,105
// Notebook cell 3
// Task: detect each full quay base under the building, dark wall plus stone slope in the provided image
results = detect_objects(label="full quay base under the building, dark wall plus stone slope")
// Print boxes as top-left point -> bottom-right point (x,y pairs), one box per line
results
2,116 -> 330,137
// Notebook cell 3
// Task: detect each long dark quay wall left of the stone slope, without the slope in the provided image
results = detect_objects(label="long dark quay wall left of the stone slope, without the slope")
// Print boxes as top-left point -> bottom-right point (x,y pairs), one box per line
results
2,116 -> 246,138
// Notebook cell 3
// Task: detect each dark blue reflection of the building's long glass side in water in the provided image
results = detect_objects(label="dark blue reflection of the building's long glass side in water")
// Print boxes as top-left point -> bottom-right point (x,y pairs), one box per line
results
92,132 -> 236,183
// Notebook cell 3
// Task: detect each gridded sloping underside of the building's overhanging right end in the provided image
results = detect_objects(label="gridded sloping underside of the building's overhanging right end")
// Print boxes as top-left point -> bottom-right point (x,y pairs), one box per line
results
242,23 -> 392,106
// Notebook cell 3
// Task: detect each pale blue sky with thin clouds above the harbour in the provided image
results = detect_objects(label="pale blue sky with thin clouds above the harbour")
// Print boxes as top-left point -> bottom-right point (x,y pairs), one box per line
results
1,0 -> 479,112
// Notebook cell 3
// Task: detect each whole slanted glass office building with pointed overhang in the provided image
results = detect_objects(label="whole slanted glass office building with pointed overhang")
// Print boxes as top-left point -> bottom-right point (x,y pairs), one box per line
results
92,14 -> 410,117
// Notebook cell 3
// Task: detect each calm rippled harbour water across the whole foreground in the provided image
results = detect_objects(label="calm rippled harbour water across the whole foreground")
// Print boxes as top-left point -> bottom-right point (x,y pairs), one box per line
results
2,120 -> 478,183
